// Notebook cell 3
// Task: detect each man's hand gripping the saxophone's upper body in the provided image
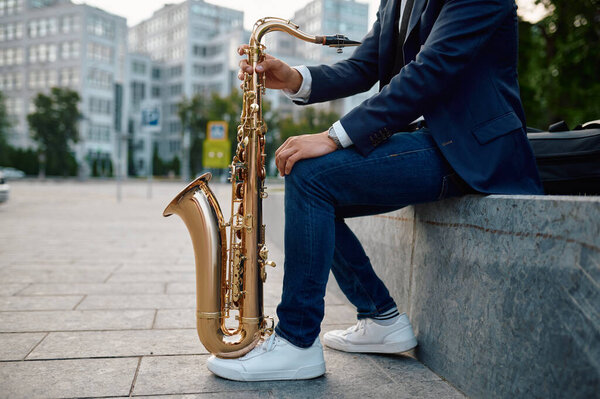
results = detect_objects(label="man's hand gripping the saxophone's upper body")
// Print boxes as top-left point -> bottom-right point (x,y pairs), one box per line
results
238,44 -> 302,93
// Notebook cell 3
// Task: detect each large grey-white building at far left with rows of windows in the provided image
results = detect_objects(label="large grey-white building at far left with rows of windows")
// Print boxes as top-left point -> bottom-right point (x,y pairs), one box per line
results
0,0 -> 127,174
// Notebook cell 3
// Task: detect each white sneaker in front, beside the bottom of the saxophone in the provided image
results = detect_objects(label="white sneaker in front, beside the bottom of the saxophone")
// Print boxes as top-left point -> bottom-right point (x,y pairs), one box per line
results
206,333 -> 325,381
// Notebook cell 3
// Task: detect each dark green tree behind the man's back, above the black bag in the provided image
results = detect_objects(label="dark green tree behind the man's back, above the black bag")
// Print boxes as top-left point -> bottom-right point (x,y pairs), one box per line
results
519,0 -> 600,128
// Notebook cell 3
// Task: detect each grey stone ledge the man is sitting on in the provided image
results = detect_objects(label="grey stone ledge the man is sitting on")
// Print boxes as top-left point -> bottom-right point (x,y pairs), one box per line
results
265,191 -> 600,398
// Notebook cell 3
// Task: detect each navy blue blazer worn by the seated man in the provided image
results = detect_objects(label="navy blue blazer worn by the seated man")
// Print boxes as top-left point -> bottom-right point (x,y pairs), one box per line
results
308,0 -> 543,194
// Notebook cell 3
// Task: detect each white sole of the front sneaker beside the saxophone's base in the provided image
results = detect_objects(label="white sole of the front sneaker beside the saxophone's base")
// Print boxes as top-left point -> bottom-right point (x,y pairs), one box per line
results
207,363 -> 325,381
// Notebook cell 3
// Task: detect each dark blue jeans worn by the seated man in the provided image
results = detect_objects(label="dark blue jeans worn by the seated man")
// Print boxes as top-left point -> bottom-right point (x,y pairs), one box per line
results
275,129 -> 462,348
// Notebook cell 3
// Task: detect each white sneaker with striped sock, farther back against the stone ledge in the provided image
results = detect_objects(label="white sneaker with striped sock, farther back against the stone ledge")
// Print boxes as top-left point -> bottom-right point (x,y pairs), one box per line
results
323,313 -> 417,353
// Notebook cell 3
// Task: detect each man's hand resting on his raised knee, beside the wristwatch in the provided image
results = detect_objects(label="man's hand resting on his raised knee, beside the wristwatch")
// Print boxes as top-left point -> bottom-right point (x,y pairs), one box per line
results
275,131 -> 337,176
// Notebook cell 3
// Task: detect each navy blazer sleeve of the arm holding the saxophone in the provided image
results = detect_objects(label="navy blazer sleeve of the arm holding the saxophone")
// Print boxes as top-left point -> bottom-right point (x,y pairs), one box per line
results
297,1 -> 385,105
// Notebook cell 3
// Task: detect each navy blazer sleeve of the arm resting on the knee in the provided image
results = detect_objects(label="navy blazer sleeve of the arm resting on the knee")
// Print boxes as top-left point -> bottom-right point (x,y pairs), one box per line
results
340,0 -> 514,155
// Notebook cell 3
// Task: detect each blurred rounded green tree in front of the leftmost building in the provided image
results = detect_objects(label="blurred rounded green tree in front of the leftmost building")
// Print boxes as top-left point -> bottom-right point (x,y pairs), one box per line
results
27,87 -> 81,176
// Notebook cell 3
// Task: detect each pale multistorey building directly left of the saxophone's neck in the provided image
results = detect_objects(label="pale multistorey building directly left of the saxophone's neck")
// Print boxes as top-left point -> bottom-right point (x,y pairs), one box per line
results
129,0 -> 248,166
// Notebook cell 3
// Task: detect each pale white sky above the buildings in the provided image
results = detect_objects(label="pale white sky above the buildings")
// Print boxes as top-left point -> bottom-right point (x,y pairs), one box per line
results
73,0 -> 543,29
